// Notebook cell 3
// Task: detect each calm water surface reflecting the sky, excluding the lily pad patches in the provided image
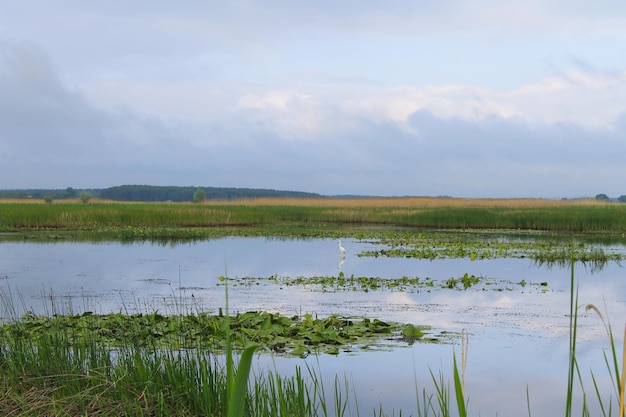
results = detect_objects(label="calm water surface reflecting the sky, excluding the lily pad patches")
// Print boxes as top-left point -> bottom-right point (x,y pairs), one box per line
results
0,238 -> 626,416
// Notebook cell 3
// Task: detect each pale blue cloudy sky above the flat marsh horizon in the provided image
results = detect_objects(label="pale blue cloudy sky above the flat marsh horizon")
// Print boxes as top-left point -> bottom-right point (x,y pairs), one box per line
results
0,0 -> 626,198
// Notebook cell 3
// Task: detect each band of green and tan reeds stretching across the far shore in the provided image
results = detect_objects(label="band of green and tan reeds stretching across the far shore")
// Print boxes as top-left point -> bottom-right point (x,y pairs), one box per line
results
0,198 -> 626,238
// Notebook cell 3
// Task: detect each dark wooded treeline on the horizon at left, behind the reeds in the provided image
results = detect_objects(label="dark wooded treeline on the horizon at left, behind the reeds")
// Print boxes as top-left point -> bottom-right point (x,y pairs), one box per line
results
0,185 -> 322,202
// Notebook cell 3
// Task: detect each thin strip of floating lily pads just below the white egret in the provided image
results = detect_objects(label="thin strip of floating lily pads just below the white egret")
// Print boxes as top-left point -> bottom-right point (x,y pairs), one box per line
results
218,272 -> 548,292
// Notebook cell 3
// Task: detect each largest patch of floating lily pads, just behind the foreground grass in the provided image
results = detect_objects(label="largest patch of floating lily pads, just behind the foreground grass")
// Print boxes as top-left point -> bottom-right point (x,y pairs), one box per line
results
0,311 -> 442,357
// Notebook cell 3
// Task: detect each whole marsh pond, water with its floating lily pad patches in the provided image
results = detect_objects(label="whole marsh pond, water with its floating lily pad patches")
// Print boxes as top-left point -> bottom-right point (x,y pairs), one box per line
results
0,199 -> 626,416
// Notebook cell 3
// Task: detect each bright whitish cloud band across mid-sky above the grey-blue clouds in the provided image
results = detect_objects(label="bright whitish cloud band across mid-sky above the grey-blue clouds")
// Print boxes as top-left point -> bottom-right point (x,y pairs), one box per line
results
79,71 -> 626,133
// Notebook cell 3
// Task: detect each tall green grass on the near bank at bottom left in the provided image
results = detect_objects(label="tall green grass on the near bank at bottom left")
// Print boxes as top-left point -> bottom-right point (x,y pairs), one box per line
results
0,314 -> 356,417
